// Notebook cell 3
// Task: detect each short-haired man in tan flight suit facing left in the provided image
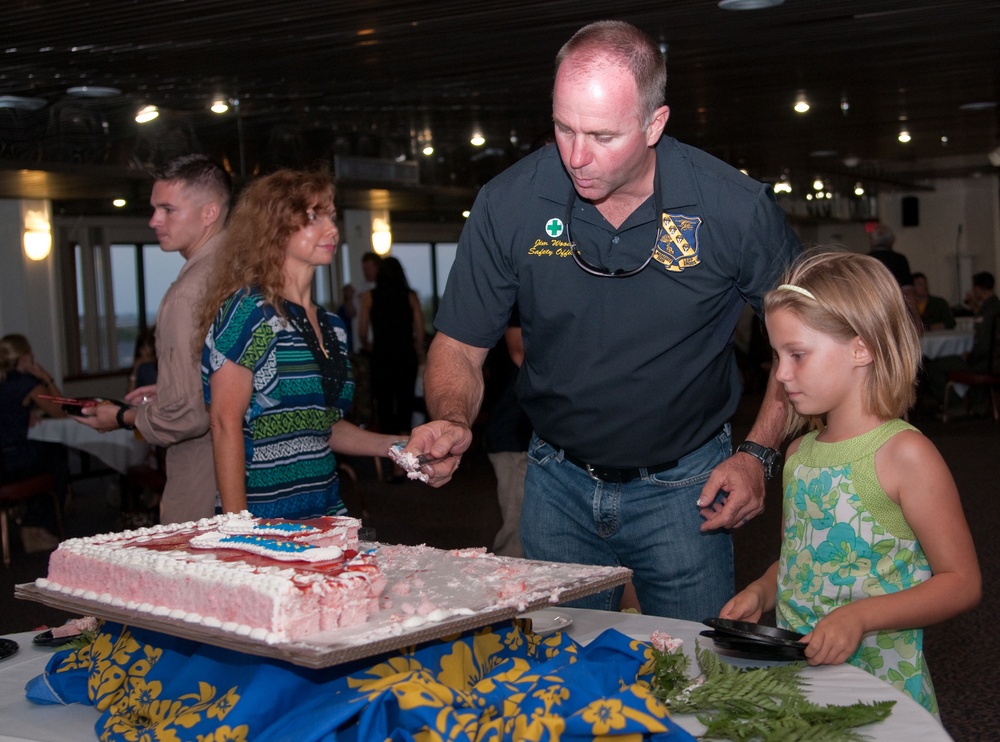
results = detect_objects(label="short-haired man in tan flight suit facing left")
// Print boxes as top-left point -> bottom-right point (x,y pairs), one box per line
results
76,155 -> 232,523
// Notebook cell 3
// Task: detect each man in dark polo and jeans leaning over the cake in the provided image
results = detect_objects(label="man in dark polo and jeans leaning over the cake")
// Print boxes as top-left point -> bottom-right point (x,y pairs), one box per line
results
407,21 -> 800,620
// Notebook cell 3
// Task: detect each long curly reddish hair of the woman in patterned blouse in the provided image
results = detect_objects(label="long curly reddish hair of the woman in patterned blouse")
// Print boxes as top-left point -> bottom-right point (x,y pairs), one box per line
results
197,170 -> 333,342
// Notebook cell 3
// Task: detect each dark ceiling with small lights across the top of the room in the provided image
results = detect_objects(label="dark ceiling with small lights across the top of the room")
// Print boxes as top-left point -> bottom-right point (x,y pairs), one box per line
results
0,0 -> 1000,208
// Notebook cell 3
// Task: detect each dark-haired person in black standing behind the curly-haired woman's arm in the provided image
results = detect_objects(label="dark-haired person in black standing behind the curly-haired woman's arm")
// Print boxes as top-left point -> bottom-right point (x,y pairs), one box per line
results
358,257 -> 424,434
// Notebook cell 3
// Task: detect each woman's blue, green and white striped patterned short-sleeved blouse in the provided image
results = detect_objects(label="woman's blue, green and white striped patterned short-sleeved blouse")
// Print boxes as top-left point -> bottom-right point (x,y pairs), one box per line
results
201,289 -> 354,518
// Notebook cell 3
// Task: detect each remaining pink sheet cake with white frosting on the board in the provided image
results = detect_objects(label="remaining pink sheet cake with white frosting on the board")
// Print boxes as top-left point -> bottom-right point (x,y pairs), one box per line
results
36,512 -> 385,643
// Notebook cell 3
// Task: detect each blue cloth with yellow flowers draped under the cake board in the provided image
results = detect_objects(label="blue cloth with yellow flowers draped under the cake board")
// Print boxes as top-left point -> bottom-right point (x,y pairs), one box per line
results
26,620 -> 694,742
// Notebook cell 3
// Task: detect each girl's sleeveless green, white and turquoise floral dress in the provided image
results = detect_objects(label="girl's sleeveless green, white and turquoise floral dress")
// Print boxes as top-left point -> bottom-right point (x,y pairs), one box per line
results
776,420 -> 937,714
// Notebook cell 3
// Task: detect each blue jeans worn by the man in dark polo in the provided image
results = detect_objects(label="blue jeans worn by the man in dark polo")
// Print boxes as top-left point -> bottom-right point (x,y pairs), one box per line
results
521,424 -> 735,621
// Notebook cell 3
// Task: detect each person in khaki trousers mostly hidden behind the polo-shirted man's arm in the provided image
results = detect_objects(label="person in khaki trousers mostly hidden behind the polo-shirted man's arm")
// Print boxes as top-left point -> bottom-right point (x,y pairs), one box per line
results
483,308 -> 531,557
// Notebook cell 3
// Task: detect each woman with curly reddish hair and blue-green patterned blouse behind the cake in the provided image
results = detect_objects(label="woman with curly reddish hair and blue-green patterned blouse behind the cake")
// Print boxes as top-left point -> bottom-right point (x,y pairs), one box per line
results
201,170 -> 396,518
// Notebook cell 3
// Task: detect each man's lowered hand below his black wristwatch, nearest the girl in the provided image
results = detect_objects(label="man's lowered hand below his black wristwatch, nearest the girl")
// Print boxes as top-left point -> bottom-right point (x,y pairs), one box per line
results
698,453 -> 764,531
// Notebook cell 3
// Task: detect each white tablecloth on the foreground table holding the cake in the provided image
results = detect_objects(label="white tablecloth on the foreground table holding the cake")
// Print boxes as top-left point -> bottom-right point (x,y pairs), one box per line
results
0,607 -> 951,742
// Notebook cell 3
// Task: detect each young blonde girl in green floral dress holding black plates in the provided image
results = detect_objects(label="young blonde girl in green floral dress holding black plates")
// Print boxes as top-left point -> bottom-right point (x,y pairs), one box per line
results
720,252 -> 981,713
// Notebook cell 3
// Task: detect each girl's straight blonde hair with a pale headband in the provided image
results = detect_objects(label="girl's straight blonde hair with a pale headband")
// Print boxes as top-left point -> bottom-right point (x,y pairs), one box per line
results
764,248 -> 920,435
